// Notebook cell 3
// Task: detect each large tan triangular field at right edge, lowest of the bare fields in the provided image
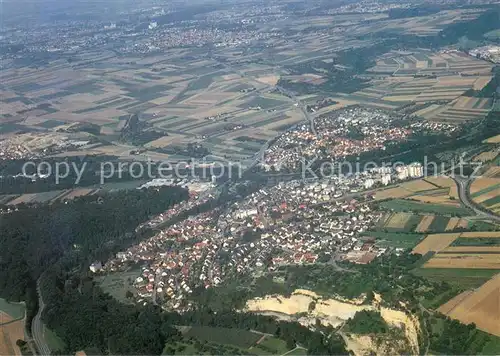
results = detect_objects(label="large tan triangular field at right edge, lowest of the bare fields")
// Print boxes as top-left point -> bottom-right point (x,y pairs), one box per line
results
438,274 -> 500,336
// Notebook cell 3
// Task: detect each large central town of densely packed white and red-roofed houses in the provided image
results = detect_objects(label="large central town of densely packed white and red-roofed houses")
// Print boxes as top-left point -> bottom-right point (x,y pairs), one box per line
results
103,163 -> 423,311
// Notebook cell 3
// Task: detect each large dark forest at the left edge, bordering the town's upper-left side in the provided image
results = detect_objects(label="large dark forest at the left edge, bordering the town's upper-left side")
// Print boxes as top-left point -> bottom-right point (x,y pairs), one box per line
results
0,187 -> 188,301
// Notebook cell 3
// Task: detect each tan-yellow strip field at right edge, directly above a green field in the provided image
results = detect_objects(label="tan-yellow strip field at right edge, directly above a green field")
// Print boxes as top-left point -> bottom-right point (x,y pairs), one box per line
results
424,253 -> 500,269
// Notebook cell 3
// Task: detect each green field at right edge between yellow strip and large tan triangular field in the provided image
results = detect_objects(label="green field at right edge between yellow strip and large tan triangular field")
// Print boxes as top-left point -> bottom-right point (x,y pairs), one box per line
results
412,268 -> 500,290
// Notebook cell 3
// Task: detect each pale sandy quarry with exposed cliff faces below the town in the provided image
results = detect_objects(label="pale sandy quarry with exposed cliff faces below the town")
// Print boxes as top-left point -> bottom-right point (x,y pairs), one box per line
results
245,289 -> 420,355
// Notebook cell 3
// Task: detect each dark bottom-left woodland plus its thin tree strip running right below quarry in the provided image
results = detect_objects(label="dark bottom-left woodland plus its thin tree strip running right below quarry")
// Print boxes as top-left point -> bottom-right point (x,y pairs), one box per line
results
41,260 -> 347,355
